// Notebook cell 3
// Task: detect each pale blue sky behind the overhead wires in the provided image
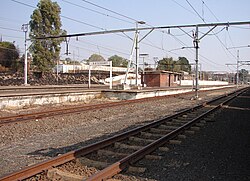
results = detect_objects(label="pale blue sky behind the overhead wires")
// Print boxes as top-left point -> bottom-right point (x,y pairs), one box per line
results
0,0 -> 250,72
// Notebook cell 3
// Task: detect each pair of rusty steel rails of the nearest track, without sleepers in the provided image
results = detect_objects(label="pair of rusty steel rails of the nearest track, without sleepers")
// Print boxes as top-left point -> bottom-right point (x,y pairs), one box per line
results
0,89 -> 245,181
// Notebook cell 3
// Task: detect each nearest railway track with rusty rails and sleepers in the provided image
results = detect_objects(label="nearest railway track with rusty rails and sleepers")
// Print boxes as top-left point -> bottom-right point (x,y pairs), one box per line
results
0,89 -> 246,181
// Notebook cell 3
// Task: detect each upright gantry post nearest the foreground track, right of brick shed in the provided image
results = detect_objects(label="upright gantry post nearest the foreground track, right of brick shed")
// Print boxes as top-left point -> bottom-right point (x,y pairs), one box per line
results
194,26 -> 199,99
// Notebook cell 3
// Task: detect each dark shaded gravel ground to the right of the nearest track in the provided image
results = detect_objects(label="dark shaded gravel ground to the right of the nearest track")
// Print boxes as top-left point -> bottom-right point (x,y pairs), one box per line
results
119,88 -> 250,181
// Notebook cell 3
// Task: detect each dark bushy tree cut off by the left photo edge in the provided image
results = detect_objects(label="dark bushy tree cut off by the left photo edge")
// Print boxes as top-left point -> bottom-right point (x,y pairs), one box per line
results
0,42 -> 19,69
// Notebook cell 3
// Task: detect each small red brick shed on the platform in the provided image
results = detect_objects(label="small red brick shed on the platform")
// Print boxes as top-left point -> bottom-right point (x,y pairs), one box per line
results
141,70 -> 181,87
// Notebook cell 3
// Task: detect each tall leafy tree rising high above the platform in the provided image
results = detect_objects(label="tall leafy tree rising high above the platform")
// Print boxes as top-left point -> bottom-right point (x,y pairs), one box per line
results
29,0 -> 66,72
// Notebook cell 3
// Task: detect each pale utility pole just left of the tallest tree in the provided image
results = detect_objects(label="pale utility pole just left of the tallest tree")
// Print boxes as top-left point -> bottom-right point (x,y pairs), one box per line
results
22,24 -> 28,85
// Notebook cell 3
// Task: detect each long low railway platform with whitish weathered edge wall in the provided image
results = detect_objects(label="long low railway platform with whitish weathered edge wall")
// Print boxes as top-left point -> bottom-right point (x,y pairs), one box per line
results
0,85 -> 234,109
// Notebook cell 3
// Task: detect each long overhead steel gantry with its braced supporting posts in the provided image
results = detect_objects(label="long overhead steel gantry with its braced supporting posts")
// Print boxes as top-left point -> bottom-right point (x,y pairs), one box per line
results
29,21 -> 250,98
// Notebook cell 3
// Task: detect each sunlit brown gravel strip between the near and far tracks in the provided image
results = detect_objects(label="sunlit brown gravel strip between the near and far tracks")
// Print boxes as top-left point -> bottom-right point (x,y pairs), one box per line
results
0,88 -> 242,176
